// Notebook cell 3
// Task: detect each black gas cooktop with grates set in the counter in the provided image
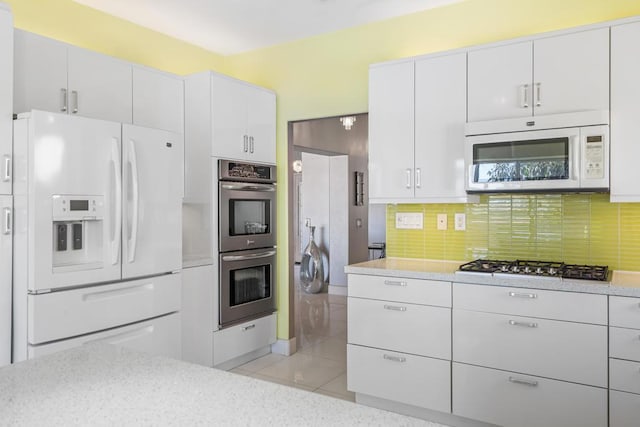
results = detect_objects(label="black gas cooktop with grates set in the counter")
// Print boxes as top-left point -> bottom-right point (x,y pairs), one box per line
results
458,259 -> 609,282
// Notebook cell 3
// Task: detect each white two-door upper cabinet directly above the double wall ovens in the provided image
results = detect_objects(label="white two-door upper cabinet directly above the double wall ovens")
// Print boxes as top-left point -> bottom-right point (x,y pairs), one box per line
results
211,73 -> 276,163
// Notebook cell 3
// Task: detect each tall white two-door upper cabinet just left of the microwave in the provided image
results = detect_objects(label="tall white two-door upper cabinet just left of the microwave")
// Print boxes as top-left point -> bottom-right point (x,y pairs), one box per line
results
369,53 -> 473,203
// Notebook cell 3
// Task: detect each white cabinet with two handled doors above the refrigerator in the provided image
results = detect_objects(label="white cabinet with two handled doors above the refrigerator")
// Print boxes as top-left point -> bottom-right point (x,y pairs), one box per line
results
14,30 -> 132,123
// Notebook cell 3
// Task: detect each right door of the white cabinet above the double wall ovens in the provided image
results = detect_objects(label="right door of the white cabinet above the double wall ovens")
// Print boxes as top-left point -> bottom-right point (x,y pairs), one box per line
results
244,86 -> 276,164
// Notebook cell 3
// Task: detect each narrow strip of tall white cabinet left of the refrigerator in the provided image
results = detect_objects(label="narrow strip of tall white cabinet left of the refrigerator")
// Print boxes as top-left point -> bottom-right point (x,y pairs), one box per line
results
0,3 -> 13,367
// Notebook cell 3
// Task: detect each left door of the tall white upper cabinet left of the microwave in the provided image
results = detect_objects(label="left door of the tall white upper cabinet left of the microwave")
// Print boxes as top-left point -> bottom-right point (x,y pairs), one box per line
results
369,62 -> 414,202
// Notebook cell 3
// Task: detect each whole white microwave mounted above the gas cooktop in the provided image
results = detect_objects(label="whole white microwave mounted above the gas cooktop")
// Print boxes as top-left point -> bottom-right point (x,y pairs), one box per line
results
465,111 -> 609,193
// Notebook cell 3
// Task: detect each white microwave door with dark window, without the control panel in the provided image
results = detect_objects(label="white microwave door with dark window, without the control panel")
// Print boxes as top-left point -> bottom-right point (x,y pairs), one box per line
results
465,128 -> 581,192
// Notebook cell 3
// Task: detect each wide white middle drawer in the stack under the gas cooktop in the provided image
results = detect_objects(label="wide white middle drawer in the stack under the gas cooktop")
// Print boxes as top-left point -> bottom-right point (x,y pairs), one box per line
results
453,310 -> 608,387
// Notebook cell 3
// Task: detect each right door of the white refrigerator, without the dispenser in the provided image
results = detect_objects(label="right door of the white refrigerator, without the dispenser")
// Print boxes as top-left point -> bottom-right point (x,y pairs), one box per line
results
122,125 -> 184,279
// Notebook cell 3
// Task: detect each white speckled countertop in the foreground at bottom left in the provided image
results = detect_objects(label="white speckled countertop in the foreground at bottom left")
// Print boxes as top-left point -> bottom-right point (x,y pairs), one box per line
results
0,344 -> 439,427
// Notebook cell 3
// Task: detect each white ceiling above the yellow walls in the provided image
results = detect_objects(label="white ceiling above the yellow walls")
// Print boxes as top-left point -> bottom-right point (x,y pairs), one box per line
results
74,0 -> 463,55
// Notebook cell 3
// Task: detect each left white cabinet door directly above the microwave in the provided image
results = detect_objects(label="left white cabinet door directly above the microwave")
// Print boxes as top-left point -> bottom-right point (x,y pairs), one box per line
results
468,42 -> 533,122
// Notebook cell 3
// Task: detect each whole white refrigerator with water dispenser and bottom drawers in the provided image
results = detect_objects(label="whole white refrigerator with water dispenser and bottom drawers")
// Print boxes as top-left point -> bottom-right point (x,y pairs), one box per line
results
13,111 -> 184,361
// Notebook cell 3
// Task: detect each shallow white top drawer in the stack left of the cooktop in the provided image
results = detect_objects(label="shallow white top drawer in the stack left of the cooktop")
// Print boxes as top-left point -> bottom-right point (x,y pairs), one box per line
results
349,274 -> 451,307
